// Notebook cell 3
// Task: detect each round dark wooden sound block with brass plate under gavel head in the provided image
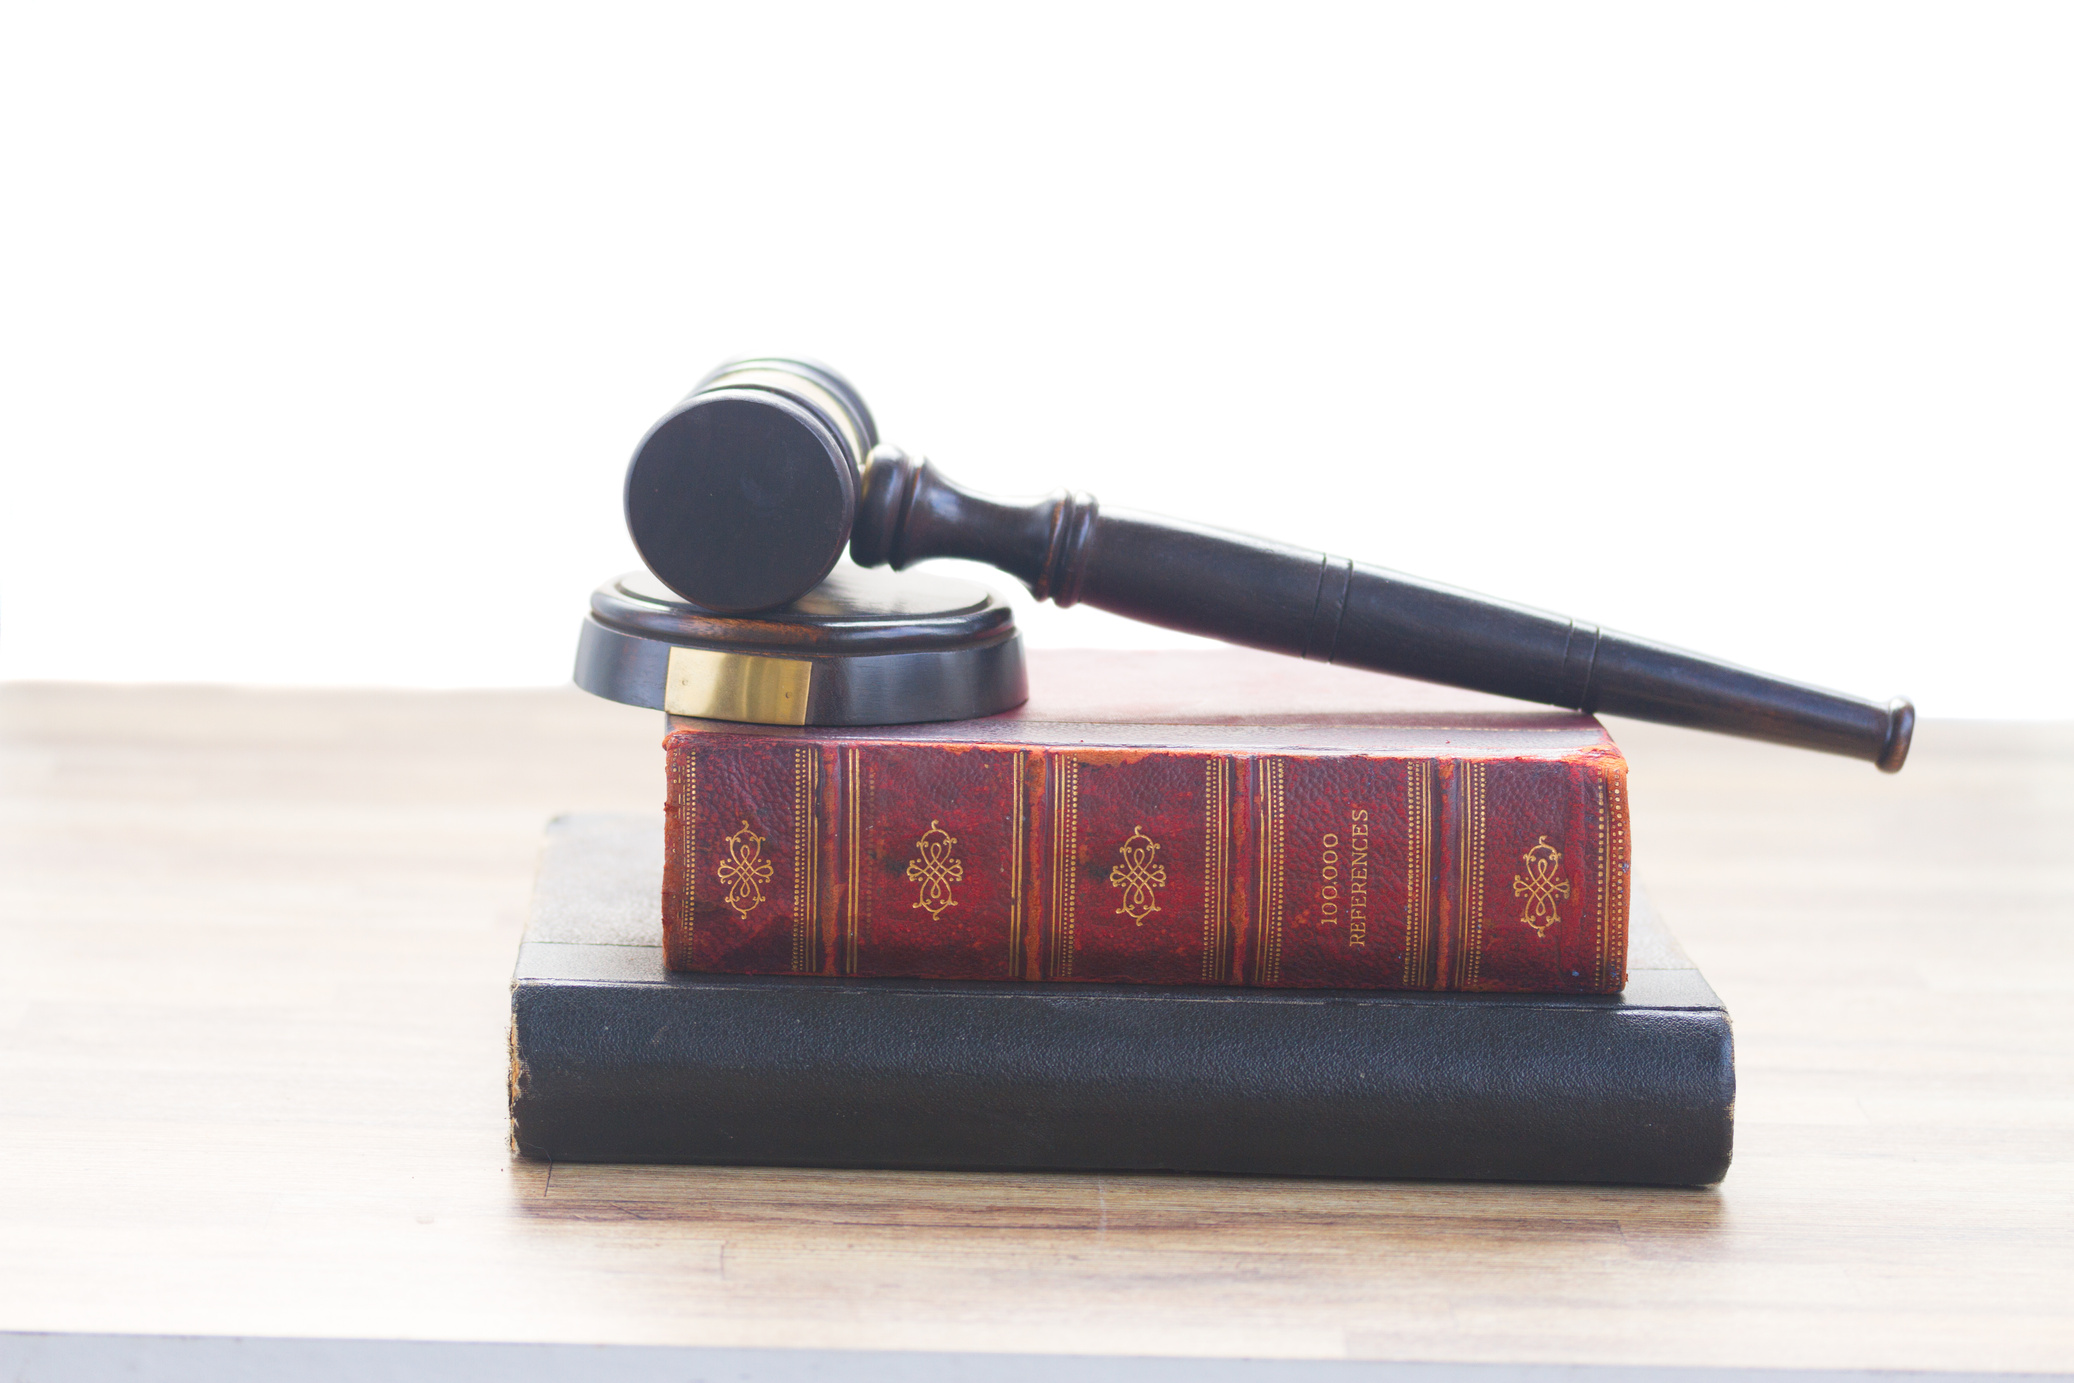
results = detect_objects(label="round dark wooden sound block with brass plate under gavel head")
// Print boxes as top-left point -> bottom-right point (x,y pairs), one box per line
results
577,564 -> 1029,726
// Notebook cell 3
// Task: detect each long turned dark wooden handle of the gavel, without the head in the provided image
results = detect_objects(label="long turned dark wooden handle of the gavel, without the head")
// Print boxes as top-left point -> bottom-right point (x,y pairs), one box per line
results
850,446 -> 1914,773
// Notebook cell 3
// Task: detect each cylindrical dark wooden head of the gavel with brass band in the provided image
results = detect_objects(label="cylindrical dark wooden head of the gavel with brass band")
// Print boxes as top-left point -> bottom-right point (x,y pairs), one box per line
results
626,357 -> 879,614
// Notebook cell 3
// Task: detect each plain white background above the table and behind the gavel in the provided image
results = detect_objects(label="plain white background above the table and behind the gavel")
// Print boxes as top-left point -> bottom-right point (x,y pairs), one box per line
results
0,4 -> 2074,715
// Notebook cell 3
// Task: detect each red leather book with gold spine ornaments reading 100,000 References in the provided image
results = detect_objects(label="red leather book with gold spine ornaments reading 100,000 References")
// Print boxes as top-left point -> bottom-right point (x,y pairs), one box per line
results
664,649 -> 1630,993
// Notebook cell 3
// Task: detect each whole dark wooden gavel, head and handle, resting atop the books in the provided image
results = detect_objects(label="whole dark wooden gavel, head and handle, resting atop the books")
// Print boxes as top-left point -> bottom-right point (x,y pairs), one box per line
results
626,357 -> 1916,773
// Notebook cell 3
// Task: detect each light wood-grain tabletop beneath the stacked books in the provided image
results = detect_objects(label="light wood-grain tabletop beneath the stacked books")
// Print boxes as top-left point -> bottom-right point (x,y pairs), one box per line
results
0,671 -> 2074,1371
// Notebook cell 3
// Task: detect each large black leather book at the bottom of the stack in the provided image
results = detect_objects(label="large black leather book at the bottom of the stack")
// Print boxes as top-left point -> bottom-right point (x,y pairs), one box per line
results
512,815 -> 1736,1186
